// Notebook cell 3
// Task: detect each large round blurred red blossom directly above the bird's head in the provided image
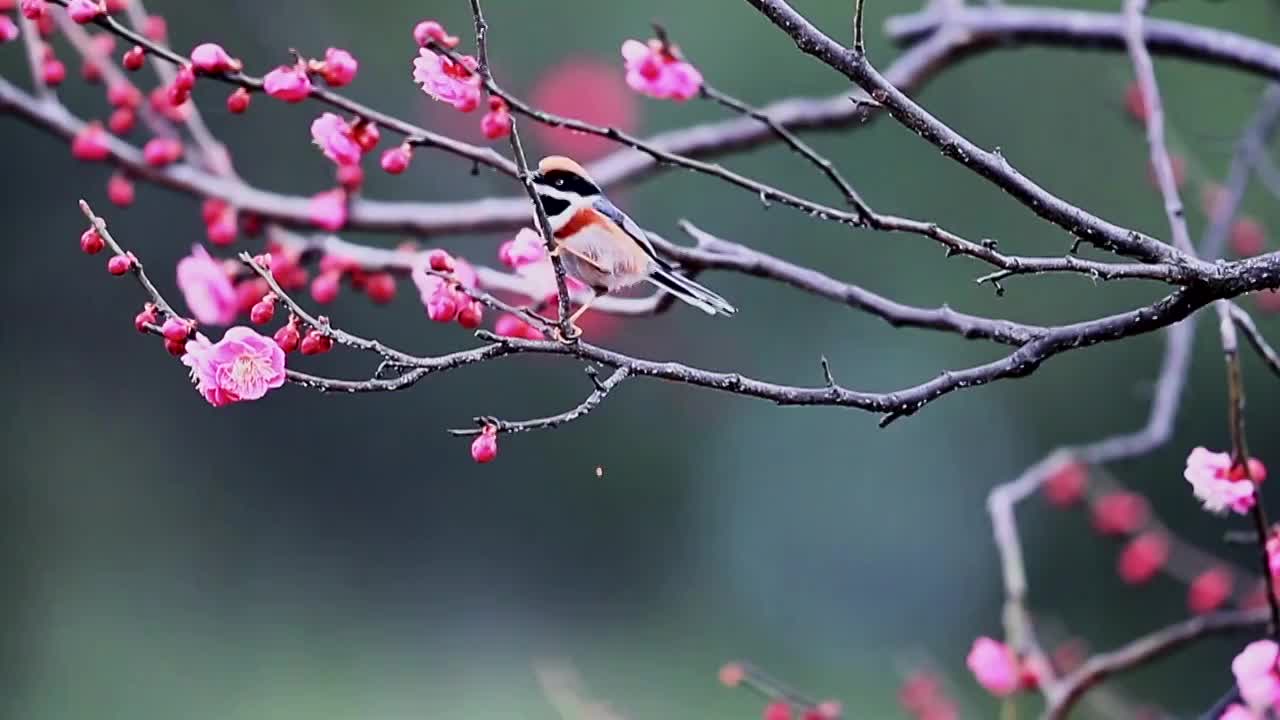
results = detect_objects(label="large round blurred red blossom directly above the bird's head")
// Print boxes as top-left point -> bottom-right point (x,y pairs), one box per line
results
531,58 -> 639,160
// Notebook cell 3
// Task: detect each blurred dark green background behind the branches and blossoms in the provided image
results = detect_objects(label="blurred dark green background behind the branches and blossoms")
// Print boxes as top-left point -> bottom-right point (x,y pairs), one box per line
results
0,0 -> 1280,720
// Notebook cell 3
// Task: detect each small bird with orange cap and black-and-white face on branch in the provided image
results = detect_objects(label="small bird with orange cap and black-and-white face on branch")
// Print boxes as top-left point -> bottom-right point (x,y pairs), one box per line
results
532,155 -> 737,329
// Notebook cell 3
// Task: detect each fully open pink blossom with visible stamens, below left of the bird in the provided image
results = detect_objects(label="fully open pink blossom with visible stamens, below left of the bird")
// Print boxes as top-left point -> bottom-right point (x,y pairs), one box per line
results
182,325 -> 284,407
